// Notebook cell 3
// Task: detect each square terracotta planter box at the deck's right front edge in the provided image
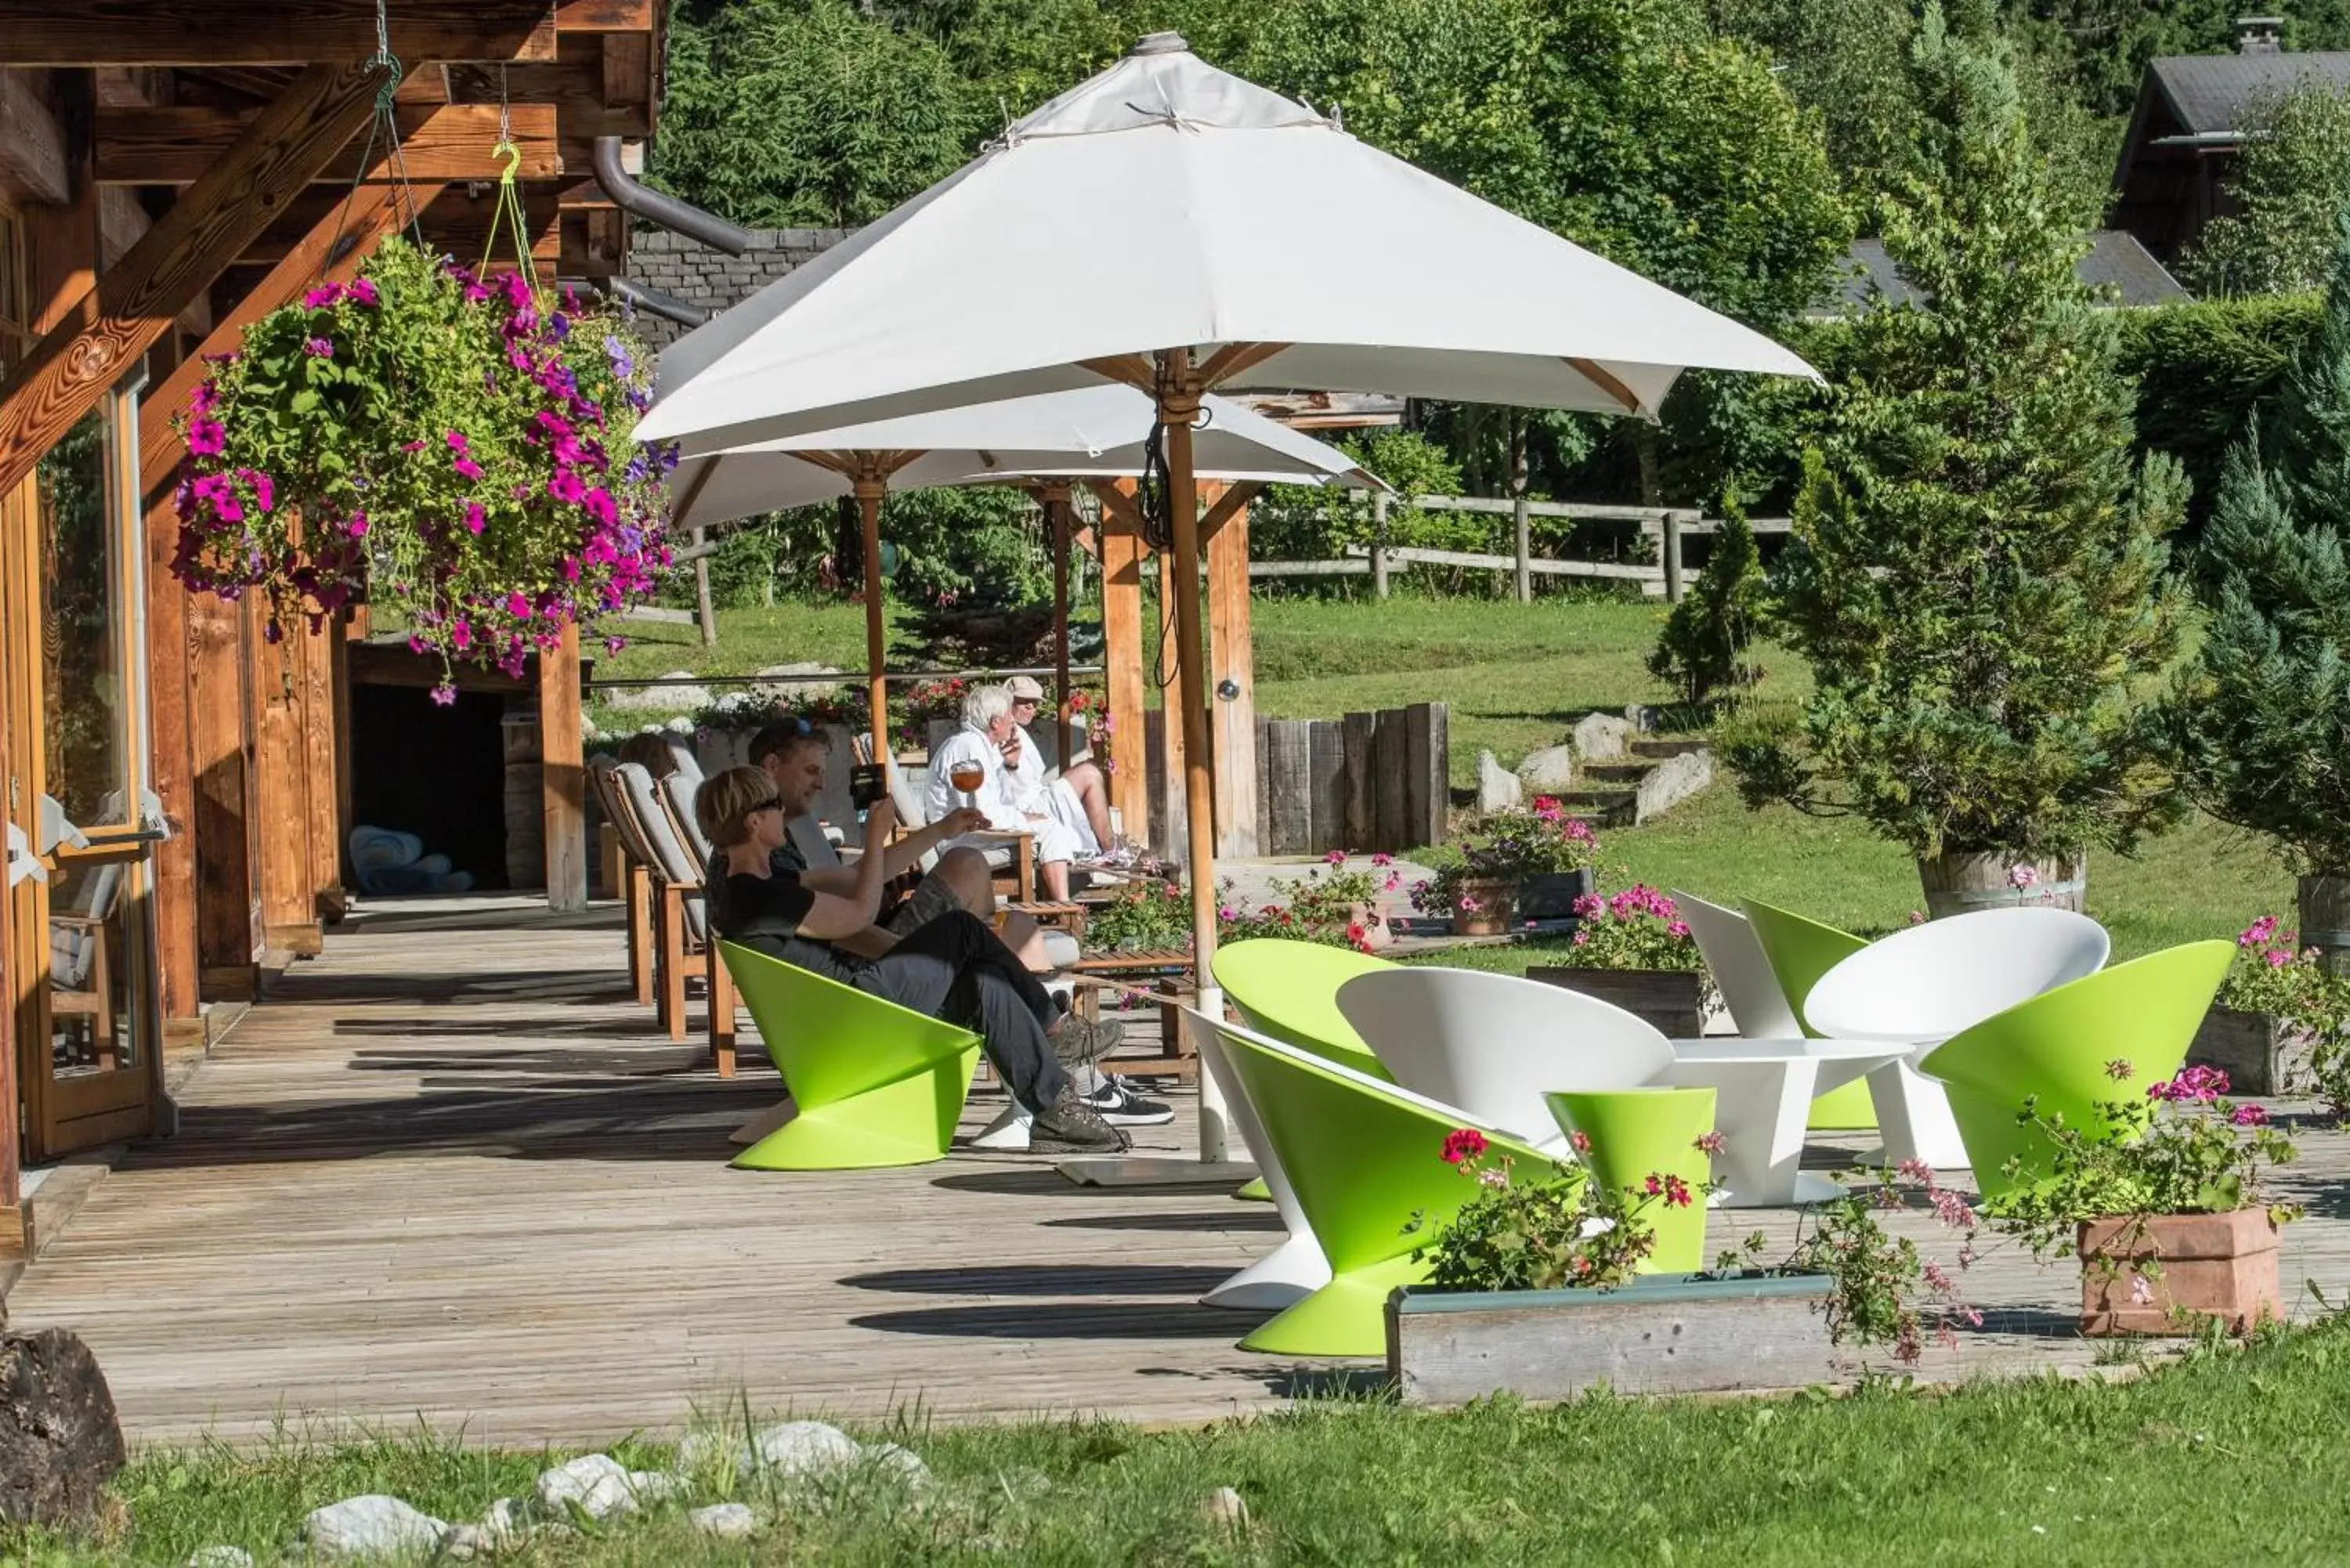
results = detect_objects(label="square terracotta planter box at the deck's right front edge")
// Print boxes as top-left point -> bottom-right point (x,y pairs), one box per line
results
2077,1209 -> 2284,1335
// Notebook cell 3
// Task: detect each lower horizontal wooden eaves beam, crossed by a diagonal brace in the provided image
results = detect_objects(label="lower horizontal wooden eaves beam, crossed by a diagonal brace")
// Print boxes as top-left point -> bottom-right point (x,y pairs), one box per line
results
99,103 -> 564,186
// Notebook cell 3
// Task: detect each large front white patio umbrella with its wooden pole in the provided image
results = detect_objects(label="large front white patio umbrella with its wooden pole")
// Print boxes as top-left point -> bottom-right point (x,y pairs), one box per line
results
637,33 -> 1814,1159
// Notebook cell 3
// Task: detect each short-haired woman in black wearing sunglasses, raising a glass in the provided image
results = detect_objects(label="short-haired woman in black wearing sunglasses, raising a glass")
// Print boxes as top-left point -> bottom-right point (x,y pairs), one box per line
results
693,768 -> 1128,1152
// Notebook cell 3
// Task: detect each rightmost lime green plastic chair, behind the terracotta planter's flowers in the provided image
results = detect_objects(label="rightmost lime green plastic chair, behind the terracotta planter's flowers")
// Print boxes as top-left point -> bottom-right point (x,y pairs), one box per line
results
1918,943 -> 2235,1197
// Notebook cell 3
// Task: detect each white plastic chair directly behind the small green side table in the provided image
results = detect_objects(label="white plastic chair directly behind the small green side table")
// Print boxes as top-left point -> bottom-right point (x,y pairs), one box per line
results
1337,966 -> 1673,1152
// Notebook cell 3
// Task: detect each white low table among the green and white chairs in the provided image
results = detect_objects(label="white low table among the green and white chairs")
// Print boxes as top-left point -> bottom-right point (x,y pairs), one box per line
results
1664,1035 -> 1906,1209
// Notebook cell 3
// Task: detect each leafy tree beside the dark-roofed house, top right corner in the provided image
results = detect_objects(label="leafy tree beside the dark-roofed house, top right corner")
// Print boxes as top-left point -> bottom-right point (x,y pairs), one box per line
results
2178,80 -> 2350,294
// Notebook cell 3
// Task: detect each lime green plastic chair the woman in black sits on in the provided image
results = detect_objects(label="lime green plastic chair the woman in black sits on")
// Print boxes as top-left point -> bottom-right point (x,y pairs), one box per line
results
719,943 -> 980,1171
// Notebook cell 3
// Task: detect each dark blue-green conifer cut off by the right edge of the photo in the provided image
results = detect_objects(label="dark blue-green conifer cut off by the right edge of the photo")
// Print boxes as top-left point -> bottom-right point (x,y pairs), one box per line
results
2169,228 -> 2350,883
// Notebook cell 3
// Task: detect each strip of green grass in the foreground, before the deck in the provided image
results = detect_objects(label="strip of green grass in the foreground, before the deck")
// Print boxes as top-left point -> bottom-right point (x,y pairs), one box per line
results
32,1321 -> 2350,1568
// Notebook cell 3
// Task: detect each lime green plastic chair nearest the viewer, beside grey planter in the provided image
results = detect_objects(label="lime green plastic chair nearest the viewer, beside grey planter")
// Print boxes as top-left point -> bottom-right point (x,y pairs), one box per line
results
1217,1025 -> 1551,1357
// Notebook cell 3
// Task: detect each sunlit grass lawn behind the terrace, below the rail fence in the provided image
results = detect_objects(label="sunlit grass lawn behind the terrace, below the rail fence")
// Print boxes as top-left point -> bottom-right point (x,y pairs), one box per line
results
597,597 -> 2294,969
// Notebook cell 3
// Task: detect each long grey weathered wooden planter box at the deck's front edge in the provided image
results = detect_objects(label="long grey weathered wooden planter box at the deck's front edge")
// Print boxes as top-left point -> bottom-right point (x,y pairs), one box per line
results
1386,1274 -> 1847,1406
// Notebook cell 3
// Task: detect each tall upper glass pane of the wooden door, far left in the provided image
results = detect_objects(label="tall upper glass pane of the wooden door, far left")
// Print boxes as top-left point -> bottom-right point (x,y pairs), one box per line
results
35,411 -> 136,849
